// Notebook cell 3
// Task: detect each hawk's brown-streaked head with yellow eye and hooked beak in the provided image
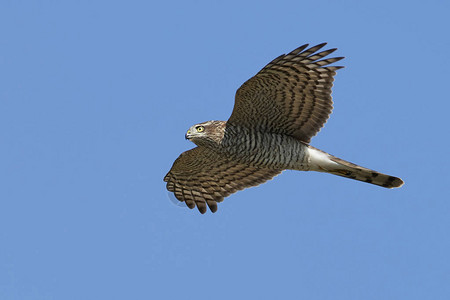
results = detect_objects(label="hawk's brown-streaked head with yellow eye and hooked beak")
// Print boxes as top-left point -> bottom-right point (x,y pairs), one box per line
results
185,121 -> 226,147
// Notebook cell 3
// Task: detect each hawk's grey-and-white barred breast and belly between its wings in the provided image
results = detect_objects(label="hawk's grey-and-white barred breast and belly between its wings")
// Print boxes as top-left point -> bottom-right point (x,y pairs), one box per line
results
221,126 -> 309,171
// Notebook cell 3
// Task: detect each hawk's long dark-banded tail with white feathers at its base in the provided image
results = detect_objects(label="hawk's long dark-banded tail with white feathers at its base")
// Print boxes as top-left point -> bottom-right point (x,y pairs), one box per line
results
308,146 -> 403,188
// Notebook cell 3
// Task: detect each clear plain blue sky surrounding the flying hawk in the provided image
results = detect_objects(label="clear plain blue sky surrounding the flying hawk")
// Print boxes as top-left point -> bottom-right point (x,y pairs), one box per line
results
0,0 -> 450,300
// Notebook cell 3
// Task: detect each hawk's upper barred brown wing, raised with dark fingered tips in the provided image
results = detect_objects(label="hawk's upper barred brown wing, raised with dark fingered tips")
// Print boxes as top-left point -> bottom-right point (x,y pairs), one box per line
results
228,43 -> 343,143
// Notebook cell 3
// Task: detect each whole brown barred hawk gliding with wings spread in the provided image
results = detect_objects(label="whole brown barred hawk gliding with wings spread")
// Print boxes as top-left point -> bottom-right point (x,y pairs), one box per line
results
164,43 -> 403,214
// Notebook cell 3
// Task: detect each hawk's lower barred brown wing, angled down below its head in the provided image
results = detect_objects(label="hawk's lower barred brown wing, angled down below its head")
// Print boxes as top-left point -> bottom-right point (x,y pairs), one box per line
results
164,147 -> 282,214
